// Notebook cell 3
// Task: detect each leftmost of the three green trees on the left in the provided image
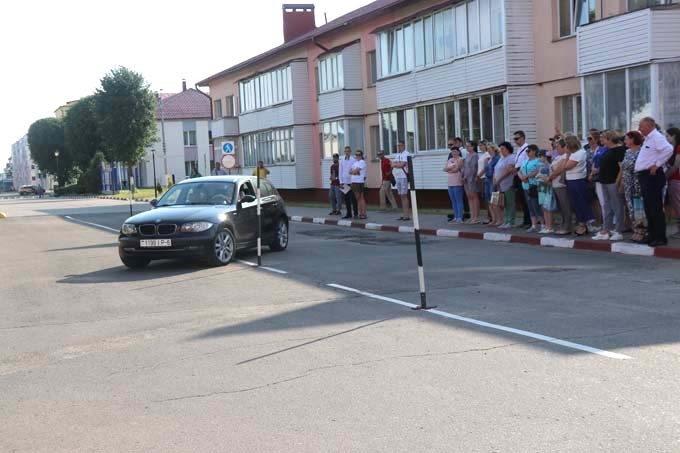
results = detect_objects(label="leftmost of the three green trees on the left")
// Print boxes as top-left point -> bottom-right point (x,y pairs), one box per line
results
28,118 -> 76,186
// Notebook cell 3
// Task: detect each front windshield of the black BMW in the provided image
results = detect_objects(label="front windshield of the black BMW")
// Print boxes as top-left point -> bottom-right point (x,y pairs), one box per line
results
157,181 -> 235,207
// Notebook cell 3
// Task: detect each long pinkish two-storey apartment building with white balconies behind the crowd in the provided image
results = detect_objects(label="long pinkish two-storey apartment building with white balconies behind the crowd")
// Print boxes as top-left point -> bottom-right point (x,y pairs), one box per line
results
199,0 -> 680,203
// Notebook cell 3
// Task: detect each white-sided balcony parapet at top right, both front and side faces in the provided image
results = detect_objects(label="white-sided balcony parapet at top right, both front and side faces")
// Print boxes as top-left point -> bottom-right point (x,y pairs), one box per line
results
577,6 -> 680,74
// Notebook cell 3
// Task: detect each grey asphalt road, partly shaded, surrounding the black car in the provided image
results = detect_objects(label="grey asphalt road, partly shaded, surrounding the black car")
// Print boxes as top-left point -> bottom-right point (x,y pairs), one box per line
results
0,199 -> 680,452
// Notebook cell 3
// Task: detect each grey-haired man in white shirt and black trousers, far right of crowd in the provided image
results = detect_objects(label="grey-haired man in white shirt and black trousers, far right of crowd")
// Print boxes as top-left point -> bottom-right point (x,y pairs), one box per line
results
635,117 -> 673,247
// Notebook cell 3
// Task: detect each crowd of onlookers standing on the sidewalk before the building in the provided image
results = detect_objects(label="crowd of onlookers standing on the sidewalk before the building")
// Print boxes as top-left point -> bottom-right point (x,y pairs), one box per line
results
330,117 -> 680,247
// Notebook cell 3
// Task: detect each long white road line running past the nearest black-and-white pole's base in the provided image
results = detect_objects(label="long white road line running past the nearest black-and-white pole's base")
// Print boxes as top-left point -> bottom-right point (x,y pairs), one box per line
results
328,283 -> 632,360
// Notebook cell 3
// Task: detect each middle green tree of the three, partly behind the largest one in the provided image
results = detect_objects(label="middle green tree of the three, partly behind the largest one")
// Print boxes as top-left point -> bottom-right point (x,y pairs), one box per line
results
64,96 -> 102,172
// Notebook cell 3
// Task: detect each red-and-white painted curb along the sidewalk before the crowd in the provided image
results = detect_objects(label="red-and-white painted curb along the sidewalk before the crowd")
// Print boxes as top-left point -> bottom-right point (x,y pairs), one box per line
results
289,215 -> 680,260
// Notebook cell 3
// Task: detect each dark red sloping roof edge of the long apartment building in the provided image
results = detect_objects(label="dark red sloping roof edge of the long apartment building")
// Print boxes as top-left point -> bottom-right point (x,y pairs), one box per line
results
197,0 -> 409,86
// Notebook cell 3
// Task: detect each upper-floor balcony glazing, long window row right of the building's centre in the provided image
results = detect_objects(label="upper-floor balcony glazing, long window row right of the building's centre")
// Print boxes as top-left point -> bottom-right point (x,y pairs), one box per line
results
378,0 -> 504,77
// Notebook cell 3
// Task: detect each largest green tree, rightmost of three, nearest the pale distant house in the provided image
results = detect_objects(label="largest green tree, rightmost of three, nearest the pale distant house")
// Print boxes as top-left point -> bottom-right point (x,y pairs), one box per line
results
95,67 -> 156,174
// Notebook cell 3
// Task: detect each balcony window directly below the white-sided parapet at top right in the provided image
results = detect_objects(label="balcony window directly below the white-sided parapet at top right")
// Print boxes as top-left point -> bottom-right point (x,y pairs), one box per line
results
584,66 -> 652,131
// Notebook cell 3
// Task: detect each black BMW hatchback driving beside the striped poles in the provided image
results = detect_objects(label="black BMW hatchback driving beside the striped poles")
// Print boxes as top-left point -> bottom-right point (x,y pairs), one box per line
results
118,176 -> 288,268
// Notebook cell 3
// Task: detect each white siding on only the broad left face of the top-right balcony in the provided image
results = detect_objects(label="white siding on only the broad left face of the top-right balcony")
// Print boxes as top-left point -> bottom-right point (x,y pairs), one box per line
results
577,9 -> 652,74
